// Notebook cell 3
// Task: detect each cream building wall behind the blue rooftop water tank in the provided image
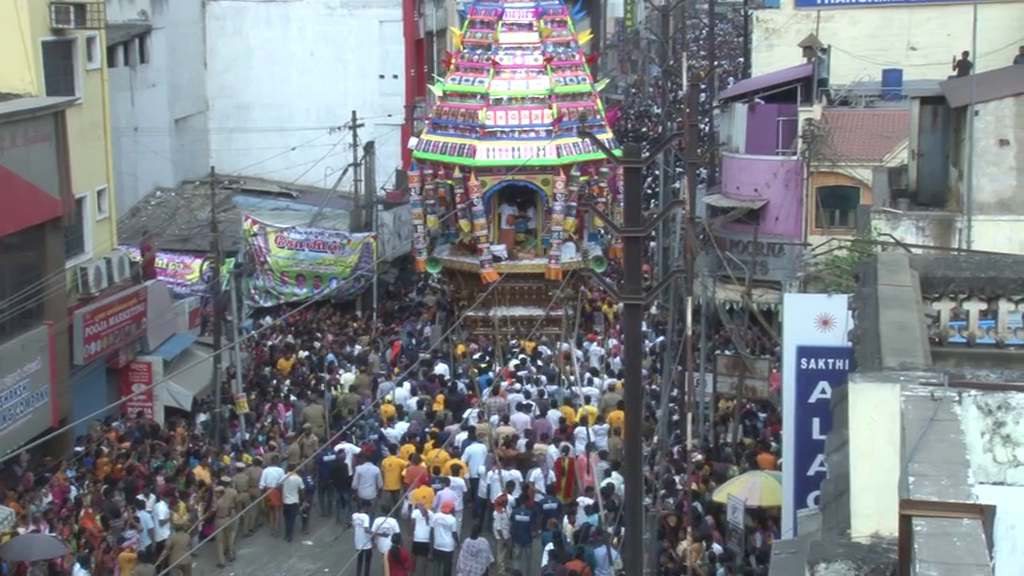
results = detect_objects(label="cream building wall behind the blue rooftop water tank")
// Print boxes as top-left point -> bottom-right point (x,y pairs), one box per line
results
751,0 -> 1024,85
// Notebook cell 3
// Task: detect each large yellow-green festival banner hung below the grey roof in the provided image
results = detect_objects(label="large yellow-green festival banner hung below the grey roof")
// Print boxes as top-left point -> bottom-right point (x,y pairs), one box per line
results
243,215 -> 377,307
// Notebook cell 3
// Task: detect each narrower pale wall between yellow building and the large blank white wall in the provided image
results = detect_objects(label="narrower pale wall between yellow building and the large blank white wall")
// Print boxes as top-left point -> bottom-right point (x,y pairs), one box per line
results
106,0 -> 210,214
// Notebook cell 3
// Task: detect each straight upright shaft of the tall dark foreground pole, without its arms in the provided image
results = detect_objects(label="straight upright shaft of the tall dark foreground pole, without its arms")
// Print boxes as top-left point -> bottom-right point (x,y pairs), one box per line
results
622,142 -> 644,575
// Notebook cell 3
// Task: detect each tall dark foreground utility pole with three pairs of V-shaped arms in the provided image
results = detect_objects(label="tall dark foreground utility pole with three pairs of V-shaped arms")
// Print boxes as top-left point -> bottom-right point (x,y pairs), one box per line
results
579,131 -> 684,576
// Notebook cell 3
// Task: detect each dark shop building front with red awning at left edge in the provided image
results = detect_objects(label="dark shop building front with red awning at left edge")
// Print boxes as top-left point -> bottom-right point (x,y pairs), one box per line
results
0,98 -> 76,453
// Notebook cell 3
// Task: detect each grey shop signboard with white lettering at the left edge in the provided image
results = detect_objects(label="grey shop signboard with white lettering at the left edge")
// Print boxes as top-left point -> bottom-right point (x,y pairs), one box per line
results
0,325 -> 59,453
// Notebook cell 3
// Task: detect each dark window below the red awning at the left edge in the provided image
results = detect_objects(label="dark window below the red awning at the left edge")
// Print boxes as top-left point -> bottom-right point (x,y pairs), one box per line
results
0,224 -> 46,342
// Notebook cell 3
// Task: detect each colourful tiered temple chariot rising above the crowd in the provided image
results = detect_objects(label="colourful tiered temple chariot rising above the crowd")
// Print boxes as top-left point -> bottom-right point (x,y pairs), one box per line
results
409,0 -> 622,336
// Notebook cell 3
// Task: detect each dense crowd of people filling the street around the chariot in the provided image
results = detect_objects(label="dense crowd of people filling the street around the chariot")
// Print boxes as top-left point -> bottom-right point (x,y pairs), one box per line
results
0,11 -> 781,576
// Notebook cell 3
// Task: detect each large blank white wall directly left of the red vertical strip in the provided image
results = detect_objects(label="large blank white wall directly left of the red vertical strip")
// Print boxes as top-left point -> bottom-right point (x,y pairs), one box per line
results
206,0 -> 406,188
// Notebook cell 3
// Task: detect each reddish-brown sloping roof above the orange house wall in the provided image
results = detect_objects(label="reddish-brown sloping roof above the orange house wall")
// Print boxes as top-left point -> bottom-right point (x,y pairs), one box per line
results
815,108 -> 910,164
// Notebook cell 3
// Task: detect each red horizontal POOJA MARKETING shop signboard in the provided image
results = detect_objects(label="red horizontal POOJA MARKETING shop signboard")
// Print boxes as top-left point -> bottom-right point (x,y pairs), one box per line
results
72,285 -> 148,365
